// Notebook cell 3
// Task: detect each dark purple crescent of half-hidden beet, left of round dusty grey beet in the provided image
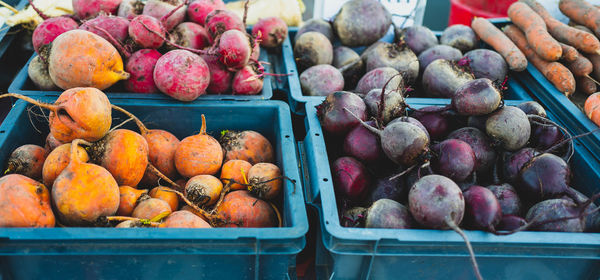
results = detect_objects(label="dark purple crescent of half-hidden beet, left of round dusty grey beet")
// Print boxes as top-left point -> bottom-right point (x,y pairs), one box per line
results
447,127 -> 496,171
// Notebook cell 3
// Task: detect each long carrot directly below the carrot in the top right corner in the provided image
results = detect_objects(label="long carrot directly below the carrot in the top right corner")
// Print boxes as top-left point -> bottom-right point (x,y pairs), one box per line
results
521,0 -> 600,53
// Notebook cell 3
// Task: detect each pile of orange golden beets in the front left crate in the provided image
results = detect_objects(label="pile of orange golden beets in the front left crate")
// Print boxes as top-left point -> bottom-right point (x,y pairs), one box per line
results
0,88 -> 287,228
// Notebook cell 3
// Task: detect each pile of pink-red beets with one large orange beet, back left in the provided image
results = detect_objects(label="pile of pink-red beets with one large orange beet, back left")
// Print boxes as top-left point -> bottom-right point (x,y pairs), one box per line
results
22,0 -> 287,102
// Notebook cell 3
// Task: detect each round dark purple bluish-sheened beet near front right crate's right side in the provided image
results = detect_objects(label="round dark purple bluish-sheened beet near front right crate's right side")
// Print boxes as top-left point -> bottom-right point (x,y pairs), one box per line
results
517,153 -> 570,201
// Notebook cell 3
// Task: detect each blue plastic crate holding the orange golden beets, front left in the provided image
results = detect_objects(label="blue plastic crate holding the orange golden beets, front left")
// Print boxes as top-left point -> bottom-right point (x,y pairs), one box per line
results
0,98 -> 308,280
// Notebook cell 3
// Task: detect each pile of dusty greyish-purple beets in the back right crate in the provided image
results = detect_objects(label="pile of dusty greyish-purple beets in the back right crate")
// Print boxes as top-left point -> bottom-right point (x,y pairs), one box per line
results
294,0 -> 508,98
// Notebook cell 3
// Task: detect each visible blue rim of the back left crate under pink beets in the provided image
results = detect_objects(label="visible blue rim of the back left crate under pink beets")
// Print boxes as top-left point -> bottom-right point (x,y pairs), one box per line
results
8,33 -> 273,100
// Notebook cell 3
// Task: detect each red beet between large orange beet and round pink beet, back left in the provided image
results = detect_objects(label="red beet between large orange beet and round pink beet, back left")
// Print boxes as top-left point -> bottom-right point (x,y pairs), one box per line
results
125,49 -> 161,93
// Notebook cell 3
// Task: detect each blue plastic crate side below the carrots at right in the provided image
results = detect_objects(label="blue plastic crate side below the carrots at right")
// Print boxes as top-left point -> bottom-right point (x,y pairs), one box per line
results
517,63 -> 600,164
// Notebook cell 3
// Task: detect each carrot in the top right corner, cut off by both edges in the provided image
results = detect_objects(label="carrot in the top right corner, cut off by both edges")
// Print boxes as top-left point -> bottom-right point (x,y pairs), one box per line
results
558,0 -> 600,36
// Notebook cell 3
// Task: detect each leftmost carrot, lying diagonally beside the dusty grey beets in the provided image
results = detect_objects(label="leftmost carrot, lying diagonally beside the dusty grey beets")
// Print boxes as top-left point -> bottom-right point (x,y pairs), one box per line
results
471,18 -> 527,72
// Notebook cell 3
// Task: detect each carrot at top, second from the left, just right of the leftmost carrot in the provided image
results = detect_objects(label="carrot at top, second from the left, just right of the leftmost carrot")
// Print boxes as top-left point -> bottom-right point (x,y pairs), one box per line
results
508,2 -> 562,61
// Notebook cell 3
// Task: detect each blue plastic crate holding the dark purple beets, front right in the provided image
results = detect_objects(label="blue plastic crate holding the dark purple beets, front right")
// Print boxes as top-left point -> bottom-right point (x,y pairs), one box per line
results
299,79 -> 600,279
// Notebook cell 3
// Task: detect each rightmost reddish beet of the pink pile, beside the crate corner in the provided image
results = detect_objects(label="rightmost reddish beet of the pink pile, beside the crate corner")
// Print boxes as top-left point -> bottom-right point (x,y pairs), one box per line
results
252,17 -> 287,48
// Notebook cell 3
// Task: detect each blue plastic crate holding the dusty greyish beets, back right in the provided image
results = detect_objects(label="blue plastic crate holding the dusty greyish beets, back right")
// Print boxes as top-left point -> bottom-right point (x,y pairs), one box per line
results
282,18 -> 532,115
